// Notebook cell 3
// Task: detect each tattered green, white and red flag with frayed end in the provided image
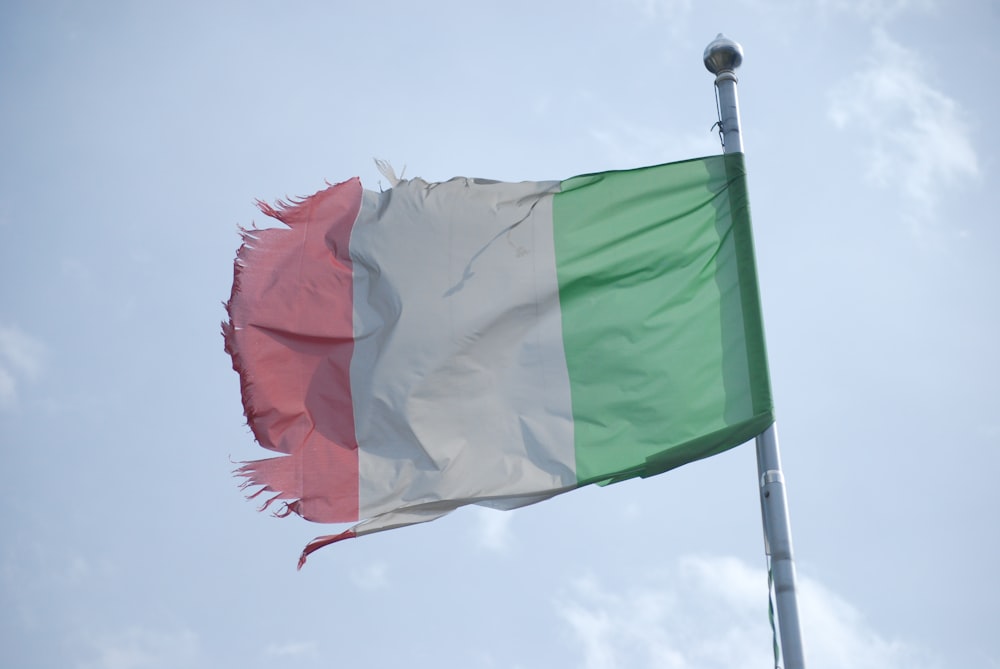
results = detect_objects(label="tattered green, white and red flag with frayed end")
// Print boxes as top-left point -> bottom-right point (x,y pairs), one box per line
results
223,154 -> 773,566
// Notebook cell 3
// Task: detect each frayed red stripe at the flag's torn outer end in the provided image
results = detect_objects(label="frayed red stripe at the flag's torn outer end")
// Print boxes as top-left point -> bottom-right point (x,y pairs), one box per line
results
222,179 -> 362,523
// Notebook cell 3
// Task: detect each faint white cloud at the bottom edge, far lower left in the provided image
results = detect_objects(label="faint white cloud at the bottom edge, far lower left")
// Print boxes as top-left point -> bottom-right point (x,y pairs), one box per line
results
78,627 -> 200,669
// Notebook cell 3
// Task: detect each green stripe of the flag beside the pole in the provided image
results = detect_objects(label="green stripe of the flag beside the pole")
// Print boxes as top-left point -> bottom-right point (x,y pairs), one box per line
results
553,154 -> 773,484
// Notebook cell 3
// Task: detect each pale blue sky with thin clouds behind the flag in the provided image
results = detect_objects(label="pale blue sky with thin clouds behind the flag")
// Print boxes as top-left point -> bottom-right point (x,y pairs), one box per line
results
0,0 -> 1000,669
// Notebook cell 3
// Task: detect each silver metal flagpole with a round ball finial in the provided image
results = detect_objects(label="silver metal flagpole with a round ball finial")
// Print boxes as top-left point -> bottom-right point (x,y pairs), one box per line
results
704,33 -> 805,669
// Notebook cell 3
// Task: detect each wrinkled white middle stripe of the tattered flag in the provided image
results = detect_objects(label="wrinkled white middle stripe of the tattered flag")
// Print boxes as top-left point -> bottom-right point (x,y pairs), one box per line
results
351,179 -> 576,521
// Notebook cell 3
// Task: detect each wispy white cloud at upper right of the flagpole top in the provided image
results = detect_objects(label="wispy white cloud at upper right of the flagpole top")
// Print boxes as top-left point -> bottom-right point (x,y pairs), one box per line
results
830,30 -> 979,222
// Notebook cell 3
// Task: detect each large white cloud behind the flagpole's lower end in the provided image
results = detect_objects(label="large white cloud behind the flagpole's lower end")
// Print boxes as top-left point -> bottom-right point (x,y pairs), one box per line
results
558,556 -> 940,669
